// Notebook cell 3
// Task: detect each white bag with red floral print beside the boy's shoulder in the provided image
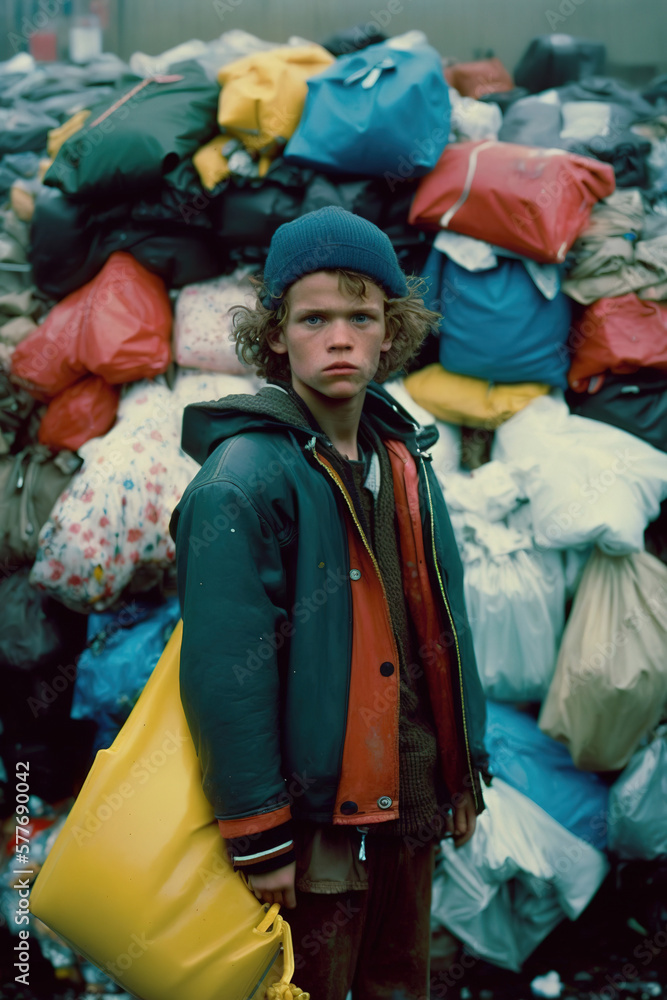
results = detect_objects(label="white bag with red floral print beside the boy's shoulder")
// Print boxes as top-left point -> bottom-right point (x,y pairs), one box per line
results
30,372 -> 256,611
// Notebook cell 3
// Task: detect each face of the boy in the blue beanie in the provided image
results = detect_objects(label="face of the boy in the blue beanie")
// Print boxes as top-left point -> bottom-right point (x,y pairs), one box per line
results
271,271 -> 392,399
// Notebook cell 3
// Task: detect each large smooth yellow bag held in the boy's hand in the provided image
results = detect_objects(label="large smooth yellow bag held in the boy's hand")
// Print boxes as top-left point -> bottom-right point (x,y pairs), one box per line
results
30,623 -> 308,1000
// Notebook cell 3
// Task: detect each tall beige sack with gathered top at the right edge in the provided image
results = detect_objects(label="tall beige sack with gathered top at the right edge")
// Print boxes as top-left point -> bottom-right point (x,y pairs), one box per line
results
539,549 -> 667,771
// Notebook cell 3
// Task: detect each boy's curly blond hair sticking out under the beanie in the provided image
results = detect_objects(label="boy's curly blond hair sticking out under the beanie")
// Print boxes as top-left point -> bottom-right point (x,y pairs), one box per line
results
230,268 -> 441,382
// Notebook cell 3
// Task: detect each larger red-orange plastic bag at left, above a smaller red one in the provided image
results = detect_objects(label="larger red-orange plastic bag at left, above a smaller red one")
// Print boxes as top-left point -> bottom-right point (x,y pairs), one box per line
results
12,253 -> 172,399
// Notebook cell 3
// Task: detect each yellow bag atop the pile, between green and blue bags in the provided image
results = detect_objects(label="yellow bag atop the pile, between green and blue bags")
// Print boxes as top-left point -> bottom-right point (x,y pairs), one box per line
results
218,44 -> 334,156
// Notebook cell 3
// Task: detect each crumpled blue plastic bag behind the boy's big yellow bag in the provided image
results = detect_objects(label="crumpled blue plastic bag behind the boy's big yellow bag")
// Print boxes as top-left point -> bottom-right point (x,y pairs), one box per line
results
70,597 -> 181,749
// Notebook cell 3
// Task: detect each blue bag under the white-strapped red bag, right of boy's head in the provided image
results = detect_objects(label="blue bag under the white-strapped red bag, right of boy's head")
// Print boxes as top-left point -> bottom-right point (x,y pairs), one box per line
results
423,250 -> 571,389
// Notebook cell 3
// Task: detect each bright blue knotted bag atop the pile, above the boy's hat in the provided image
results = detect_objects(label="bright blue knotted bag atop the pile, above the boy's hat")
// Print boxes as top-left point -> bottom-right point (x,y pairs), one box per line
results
284,40 -> 450,178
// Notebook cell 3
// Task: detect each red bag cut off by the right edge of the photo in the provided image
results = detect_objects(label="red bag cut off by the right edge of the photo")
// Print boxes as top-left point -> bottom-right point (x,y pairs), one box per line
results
567,294 -> 667,392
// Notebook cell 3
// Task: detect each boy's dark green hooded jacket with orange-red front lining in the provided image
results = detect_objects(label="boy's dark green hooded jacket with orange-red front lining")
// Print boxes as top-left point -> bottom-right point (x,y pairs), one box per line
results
170,383 -> 486,872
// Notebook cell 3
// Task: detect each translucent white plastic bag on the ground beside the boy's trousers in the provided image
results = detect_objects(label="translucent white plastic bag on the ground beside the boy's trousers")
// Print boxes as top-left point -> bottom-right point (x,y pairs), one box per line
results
431,778 -> 609,972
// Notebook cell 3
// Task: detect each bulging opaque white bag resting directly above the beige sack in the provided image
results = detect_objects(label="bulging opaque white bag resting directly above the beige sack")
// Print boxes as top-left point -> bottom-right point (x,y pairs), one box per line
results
491,396 -> 667,555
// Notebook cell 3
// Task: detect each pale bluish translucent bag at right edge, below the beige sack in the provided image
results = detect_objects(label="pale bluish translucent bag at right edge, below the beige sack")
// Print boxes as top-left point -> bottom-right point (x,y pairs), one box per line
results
607,726 -> 667,861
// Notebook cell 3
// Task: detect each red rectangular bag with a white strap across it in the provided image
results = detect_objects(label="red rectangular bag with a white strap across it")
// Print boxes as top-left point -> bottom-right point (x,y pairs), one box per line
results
409,140 -> 616,263
